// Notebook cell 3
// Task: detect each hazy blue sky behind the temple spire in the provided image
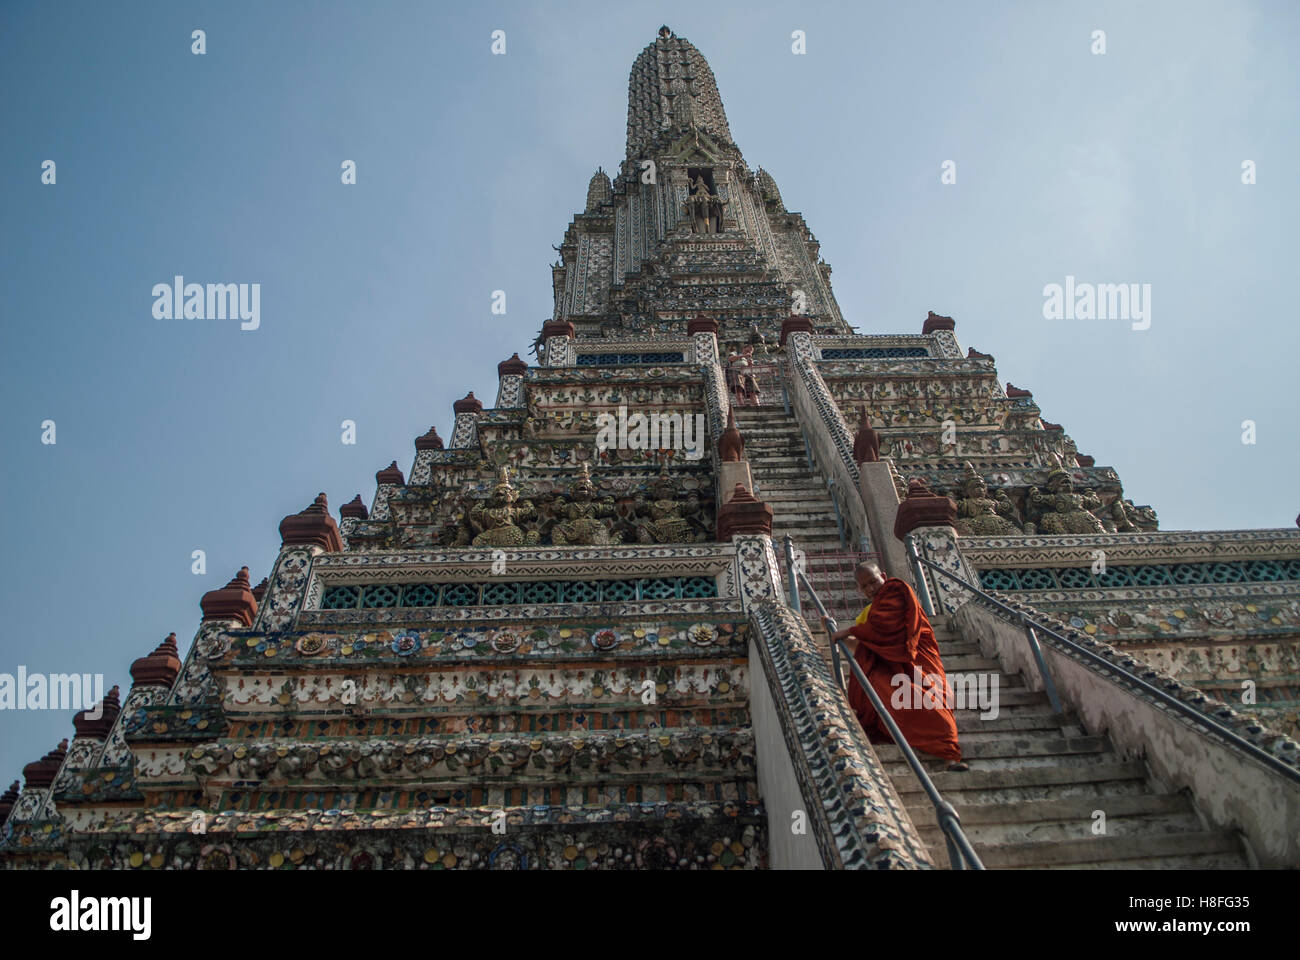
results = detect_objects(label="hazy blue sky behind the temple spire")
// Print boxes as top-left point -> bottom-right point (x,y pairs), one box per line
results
0,1 -> 1300,788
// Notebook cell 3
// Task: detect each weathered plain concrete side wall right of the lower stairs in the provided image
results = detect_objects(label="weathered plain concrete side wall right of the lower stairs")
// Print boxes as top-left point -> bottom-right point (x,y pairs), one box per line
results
954,602 -> 1300,868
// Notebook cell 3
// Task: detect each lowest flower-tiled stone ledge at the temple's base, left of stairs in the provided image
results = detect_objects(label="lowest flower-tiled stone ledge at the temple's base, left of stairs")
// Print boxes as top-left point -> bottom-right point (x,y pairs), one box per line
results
0,803 -> 767,870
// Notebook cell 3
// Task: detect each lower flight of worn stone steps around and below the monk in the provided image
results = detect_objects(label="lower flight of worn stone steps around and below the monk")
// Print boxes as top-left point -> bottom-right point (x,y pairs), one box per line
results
875,618 -> 1249,869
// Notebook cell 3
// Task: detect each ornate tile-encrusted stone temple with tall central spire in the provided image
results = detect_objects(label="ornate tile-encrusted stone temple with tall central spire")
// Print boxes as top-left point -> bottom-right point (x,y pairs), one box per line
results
0,27 -> 1300,870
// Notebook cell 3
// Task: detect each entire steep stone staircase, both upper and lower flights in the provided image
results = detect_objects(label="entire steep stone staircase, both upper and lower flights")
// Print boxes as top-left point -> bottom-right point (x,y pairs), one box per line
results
736,406 -> 1249,869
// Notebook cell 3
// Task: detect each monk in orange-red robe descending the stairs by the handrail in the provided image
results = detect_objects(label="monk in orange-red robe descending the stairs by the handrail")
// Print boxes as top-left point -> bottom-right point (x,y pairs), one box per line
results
833,562 -> 970,771
